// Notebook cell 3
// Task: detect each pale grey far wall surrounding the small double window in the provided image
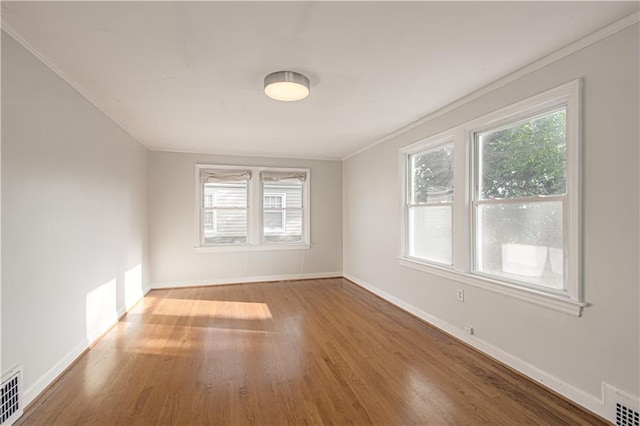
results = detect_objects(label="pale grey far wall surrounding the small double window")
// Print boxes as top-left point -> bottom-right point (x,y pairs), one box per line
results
149,152 -> 342,288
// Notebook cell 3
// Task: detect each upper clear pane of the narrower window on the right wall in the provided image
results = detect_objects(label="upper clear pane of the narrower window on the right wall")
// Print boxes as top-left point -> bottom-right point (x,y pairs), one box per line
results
409,143 -> 453,204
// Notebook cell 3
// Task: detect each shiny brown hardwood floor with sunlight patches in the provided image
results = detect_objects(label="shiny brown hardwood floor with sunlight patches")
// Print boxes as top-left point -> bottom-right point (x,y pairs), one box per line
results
18,279 -> 606,425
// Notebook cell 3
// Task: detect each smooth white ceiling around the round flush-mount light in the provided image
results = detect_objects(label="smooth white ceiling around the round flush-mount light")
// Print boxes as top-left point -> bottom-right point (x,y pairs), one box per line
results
2,1 -> 638,159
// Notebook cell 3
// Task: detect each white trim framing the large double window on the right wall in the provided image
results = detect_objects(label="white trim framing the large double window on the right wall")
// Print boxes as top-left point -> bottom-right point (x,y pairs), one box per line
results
398,80 -> 587,316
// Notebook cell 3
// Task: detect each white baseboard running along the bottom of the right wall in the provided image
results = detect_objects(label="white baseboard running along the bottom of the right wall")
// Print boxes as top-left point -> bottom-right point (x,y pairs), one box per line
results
343,274 -> 637,423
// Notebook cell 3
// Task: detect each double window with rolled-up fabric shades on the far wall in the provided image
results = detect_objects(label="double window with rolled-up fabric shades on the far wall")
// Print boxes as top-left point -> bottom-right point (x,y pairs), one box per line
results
196,165 -> 309,252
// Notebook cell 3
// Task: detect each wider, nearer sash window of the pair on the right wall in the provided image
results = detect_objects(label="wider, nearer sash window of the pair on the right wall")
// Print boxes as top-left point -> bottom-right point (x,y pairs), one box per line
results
473,106 -> 567,290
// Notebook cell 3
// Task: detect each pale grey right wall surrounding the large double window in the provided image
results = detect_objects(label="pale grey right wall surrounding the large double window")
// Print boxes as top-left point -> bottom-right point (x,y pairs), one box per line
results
343,24 -> 640,414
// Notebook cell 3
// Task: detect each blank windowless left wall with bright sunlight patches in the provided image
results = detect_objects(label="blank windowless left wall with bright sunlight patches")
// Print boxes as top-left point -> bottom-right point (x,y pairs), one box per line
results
1,34 -> 148,403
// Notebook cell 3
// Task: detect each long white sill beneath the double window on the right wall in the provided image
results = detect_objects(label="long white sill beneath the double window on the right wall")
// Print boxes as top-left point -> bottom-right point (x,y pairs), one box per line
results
398,257 -> 587,317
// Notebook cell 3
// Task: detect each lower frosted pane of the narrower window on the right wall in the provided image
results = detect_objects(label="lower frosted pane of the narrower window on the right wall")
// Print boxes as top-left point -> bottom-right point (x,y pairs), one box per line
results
409,206 -> 452,265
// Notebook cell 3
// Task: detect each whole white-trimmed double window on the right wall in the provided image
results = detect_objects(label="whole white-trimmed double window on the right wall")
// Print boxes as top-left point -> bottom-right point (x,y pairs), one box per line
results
399,81 -> 585,315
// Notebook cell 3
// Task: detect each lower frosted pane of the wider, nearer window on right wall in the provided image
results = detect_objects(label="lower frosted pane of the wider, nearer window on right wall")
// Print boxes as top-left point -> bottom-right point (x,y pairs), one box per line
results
476,201 -> 564,289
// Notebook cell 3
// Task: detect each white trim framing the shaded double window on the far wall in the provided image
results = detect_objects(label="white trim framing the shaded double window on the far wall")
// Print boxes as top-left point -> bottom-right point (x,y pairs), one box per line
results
194,164 -> 311,253
